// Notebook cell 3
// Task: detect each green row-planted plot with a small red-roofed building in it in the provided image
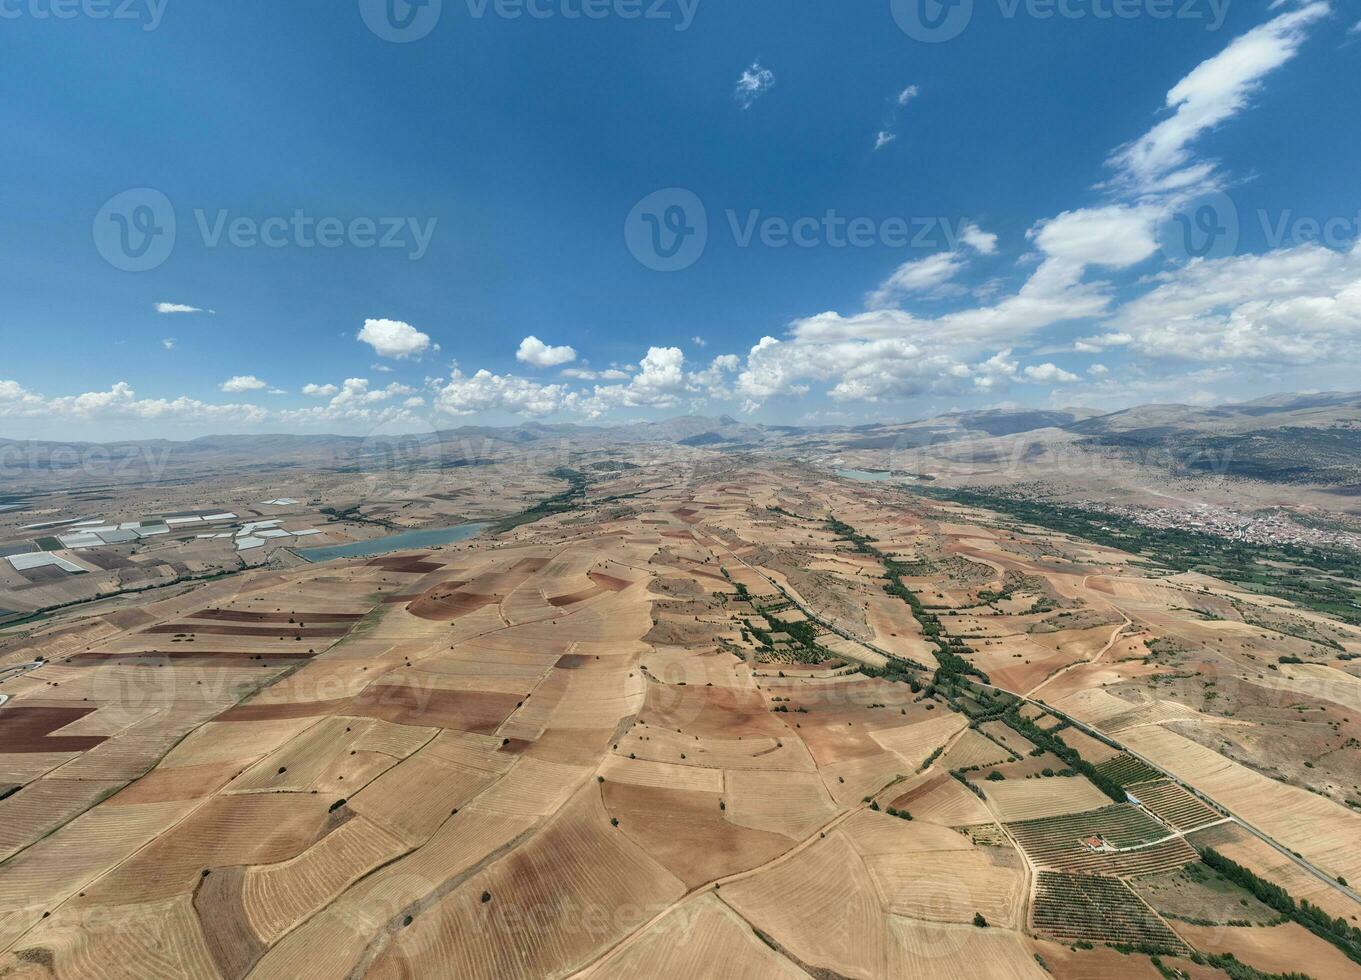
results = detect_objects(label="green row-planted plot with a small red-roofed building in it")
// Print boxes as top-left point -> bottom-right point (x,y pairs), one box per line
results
1007,803 -> 1198,878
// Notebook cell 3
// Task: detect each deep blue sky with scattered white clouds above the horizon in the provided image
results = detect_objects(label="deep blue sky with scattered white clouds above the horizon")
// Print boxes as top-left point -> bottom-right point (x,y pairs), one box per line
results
0,0 -> 1361,438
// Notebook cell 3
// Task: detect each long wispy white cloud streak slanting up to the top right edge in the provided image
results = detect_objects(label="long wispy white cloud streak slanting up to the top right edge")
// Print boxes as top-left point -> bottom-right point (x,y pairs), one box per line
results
1109,0 -> 1328,193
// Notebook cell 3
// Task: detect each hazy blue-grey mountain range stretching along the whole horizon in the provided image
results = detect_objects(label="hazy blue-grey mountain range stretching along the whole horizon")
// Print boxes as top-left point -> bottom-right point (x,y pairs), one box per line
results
0,392 -> 1361,485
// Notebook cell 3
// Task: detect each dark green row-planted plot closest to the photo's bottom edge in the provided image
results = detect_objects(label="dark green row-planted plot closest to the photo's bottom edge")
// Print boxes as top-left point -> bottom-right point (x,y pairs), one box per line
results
1032,871 -> 1190,956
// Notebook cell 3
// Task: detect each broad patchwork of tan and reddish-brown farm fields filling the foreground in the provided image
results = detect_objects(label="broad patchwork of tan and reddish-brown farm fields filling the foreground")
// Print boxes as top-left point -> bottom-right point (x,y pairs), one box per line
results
0,448 -> 1361,980
